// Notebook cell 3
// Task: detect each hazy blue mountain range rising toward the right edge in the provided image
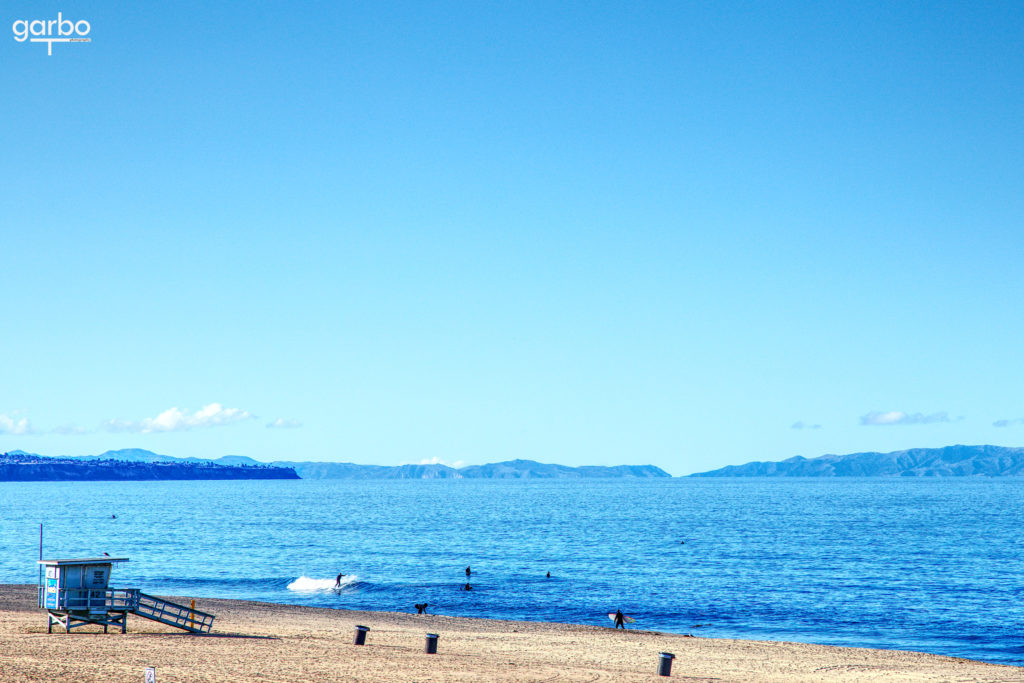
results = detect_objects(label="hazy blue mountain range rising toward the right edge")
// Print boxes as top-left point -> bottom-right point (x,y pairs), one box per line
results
690,445 -> 1024,477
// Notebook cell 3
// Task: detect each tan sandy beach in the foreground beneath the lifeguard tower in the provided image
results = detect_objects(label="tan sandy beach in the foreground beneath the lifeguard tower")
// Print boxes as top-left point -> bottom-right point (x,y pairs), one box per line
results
0,585 -> 1024,683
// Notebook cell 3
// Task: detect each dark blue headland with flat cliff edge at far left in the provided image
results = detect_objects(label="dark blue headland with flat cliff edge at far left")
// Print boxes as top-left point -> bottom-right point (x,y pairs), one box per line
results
0,451 -> 299,481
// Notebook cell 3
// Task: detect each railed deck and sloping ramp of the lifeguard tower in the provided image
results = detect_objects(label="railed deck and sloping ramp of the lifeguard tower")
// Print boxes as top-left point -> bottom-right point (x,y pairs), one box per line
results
41,588 -> 214,633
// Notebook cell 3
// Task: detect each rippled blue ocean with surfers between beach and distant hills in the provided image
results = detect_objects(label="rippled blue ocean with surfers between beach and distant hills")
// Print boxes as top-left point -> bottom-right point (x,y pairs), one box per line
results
0,478 -> 1024,665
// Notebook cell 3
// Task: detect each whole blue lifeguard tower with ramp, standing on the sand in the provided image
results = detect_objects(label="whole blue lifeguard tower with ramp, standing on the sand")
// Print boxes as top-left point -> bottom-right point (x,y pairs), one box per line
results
39,556 -> 213,633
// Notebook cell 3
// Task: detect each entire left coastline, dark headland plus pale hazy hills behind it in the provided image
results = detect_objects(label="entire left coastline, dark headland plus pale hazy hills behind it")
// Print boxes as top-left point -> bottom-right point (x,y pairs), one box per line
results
0,449 -> 672,481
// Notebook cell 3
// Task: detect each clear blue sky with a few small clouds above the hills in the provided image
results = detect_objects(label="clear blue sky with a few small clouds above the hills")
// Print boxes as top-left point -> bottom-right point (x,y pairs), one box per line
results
0,0 -> 1024,475
